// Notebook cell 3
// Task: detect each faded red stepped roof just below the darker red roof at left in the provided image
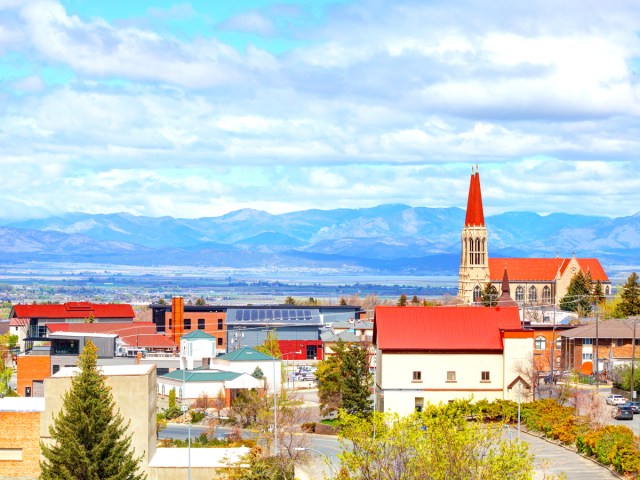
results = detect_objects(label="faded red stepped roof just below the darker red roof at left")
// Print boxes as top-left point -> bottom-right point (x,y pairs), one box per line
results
47,322 -> 177,348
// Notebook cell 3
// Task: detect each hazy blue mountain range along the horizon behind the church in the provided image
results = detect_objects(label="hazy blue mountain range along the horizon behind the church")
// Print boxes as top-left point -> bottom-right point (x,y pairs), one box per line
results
0,204 -> 640,275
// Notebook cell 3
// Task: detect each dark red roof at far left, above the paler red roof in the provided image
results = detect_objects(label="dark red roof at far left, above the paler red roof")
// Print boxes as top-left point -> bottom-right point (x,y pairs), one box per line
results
10,302 -> 134,319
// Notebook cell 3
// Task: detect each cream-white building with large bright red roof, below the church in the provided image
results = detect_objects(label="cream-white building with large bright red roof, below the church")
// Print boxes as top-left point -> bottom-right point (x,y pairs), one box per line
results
374,306 -> 533,415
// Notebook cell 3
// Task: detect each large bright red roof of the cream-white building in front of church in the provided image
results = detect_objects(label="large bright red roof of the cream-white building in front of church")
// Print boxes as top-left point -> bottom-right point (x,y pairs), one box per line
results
373,306 -> 521,351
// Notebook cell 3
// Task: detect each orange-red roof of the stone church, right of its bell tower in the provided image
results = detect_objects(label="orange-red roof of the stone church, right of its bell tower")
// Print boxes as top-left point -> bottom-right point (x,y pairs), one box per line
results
489,258 -> 609,283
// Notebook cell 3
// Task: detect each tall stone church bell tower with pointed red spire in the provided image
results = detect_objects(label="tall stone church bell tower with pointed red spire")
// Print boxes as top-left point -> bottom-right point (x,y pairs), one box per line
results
458,165 -> 489,304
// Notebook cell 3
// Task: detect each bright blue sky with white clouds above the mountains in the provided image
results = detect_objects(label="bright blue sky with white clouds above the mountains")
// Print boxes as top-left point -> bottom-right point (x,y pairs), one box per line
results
0,0 -> 640,221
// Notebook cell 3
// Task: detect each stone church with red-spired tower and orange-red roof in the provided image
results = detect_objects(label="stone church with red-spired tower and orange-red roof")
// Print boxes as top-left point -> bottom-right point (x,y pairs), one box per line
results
458,166 -> 611,306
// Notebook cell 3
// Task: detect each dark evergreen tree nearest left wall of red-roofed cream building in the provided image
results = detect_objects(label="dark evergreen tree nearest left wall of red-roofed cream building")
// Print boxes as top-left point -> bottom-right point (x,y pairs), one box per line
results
340,345 -> 373,417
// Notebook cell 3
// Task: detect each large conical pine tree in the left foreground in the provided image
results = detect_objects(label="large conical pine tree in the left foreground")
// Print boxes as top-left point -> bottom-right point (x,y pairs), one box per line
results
40,341 -> 146,480
